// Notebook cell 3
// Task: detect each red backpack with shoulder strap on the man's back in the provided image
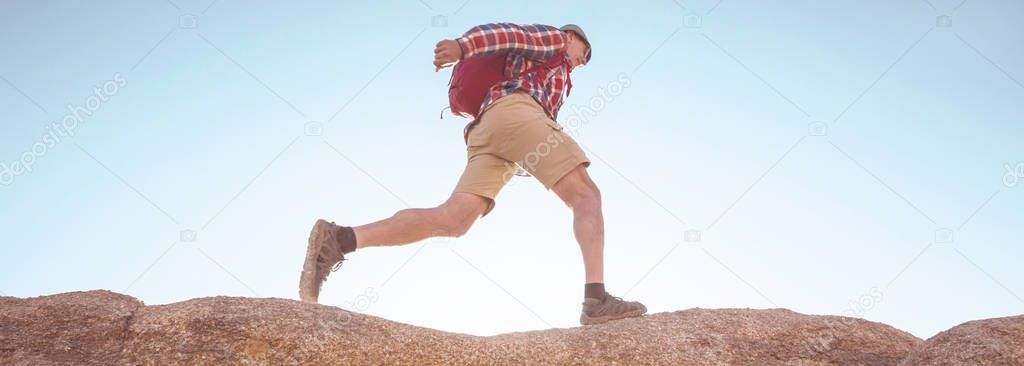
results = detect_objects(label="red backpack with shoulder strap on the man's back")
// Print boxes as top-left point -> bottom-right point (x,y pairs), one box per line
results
449,51 -> 565,120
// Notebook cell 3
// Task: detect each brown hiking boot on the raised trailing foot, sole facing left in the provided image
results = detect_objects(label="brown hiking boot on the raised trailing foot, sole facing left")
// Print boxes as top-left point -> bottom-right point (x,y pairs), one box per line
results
299,219 -> 345,303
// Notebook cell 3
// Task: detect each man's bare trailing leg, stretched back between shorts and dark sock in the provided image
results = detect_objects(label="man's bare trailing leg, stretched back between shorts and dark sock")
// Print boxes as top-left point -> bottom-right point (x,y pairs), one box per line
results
352,192 -> 490,249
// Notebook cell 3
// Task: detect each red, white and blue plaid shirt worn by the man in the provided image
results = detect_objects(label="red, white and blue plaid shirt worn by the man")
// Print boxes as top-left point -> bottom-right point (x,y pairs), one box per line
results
457,23 -> 571,119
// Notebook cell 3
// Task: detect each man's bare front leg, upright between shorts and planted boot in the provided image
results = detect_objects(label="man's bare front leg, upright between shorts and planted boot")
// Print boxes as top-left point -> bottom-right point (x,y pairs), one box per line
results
551,165 -> 604,283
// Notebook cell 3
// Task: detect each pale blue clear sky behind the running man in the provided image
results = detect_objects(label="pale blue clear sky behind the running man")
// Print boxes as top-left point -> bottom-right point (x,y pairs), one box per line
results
0,0 -> 1024,337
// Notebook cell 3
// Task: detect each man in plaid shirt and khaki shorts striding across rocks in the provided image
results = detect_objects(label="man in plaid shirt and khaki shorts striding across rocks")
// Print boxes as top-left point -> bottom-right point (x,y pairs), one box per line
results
299,23 -> 647,325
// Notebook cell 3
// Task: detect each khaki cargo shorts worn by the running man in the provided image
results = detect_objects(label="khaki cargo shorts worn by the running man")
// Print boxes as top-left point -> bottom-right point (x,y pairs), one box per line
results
455,92 -> 590,215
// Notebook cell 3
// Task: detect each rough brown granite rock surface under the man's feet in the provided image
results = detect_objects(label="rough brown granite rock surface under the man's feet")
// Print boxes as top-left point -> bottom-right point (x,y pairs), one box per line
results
0,291 -> 1024,365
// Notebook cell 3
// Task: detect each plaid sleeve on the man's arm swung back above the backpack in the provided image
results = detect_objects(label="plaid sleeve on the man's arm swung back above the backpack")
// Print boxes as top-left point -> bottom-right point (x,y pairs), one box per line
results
456,23 -> 568,60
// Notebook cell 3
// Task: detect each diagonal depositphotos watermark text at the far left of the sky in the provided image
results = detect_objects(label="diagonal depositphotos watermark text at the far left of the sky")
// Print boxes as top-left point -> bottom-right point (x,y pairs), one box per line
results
0,73 -> 127,186
